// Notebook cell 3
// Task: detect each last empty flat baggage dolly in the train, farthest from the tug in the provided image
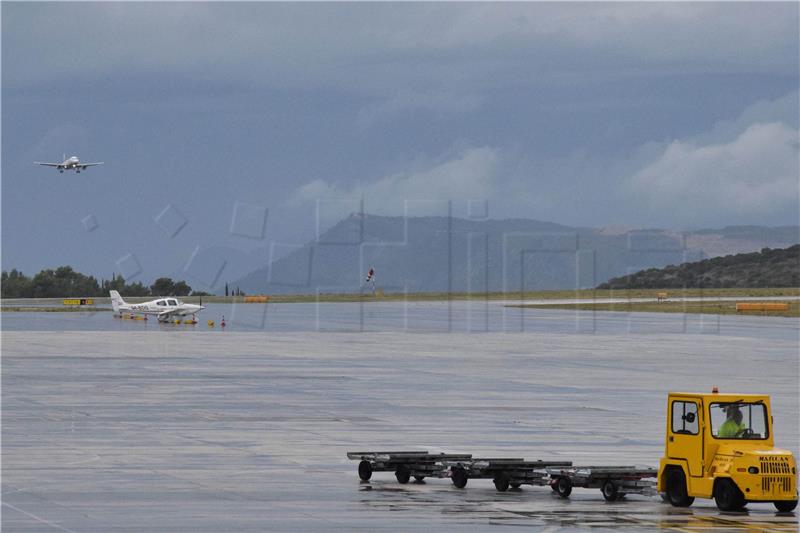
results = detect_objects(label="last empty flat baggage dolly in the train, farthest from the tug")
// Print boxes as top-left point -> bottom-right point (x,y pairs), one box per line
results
347,451 -> 472,484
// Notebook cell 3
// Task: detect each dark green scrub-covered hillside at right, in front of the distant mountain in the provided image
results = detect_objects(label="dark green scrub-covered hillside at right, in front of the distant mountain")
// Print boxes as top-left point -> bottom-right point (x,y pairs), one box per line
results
598,245 -> 800,289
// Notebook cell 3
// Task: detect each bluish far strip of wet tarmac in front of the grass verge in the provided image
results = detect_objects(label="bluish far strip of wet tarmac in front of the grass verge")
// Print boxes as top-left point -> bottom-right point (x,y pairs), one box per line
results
0,300 -> 800,340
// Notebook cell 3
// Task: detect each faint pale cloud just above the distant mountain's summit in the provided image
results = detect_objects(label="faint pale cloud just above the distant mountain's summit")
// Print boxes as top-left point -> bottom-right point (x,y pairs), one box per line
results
291,147 -> 501,215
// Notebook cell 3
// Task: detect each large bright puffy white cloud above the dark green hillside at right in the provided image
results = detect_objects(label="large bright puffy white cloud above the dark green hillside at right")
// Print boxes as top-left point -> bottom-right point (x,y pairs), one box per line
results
629,122 -> 800,226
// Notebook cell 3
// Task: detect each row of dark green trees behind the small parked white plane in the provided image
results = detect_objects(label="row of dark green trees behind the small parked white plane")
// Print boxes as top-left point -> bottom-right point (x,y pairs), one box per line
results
0,266 -> 207,298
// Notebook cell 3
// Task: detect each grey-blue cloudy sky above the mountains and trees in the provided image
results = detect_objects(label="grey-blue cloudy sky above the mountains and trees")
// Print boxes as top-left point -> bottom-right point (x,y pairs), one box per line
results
0,2 -> 800,288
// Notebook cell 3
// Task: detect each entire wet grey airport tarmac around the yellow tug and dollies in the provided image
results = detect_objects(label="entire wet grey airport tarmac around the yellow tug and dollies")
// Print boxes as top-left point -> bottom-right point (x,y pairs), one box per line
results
2,302 -> 800,532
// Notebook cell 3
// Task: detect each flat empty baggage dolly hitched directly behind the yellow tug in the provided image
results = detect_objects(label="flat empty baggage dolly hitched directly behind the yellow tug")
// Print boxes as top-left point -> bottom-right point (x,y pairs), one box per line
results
546,466 -> 658,502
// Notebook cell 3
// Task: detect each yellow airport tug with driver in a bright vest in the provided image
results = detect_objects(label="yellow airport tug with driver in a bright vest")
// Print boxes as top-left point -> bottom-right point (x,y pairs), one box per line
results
658,387 -> 798,512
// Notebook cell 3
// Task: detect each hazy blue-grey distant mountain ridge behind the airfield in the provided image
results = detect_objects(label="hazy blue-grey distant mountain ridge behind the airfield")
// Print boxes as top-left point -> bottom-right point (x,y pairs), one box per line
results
233,214 -> 800,294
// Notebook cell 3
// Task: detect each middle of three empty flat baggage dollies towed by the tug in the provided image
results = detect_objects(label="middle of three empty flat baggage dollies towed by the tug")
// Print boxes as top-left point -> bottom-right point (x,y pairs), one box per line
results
443,458 -> 572,492
